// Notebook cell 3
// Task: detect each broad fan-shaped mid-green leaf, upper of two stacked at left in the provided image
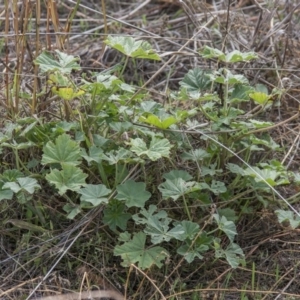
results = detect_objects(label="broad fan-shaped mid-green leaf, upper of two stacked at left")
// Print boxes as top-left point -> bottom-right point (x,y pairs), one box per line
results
42,133 -> 81,165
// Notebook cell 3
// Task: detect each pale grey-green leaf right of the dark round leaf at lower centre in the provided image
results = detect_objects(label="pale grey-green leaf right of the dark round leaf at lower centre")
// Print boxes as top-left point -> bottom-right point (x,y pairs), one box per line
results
158,178 -> 196,201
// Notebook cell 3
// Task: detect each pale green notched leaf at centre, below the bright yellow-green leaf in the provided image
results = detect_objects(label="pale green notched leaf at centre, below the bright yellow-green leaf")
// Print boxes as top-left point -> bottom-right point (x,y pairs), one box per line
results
130,137 -> 172,161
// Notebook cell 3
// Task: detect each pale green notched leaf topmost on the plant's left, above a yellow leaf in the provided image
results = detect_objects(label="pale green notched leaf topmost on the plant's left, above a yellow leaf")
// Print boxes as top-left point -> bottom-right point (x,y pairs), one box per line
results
34,50 -> 80,74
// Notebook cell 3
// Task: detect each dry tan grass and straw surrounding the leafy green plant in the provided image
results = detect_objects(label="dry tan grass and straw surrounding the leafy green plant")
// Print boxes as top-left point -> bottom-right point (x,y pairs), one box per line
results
0,0 -> 300,300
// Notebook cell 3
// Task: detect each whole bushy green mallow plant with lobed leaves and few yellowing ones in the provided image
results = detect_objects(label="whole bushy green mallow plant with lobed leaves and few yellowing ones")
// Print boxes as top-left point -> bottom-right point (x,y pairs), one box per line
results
0,37 -> 299,269
